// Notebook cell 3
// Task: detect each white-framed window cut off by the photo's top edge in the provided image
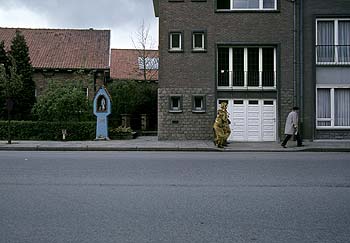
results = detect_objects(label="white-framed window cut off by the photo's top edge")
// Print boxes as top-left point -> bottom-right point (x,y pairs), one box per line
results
216,0 -> 277,10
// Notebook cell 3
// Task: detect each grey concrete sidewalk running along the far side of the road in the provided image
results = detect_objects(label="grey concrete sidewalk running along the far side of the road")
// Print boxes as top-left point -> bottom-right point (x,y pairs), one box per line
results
0,136 -> 350,152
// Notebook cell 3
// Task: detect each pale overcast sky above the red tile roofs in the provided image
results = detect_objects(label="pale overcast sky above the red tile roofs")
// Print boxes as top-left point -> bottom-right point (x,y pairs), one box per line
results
0,0 -> 158,49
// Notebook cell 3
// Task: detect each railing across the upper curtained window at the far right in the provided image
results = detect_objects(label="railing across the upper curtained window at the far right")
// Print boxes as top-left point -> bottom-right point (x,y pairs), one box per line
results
316,45 -> 350,65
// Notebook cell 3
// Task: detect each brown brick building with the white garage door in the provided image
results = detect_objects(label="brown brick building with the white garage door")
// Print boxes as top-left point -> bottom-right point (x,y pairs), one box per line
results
153,0 -> 297,141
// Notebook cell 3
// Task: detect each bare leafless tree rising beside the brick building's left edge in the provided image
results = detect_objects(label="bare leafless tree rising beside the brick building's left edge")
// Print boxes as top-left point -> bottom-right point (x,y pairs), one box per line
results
131,21 -> 159,81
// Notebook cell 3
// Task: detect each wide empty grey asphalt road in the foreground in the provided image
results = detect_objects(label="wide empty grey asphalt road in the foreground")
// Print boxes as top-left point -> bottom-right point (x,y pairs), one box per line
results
0,152 -> 350,243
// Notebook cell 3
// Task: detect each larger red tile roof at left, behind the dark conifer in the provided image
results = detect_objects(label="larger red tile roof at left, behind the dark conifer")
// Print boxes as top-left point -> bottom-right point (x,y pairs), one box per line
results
0,28 -> 110,69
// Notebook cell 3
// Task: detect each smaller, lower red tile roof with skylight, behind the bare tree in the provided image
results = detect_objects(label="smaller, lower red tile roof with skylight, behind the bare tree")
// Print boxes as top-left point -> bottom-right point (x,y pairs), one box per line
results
110,49 -> 159,81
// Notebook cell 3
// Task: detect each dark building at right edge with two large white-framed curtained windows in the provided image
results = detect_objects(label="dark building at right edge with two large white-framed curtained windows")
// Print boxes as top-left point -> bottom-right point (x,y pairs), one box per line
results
300,0 -> 350,139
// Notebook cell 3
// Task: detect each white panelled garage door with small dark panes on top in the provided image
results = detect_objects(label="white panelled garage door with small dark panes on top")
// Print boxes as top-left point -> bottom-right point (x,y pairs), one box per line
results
218,99 -> 276,141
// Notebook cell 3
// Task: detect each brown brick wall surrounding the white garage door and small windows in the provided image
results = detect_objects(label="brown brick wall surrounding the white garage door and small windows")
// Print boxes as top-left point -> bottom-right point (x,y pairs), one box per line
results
158,0 -> 294,139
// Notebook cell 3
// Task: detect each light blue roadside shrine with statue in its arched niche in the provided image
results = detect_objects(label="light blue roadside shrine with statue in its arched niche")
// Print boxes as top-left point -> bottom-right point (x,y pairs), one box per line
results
94,86 -> 111,140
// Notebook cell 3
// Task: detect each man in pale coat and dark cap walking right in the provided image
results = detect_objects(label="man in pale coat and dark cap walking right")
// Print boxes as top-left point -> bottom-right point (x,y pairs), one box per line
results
281,106 -> 303,148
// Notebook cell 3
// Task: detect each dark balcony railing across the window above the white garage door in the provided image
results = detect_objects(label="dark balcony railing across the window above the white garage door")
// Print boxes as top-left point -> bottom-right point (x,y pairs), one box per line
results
218,70 -> 276,88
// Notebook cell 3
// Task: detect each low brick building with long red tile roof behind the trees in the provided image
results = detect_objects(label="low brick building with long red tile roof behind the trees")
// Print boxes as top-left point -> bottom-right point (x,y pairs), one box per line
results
0,28 -> 110,98
